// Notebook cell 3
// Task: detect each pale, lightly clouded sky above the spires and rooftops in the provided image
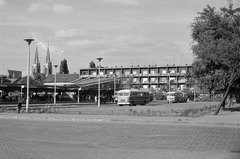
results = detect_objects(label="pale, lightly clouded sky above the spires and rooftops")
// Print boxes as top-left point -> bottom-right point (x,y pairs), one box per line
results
0,0 -> 240,74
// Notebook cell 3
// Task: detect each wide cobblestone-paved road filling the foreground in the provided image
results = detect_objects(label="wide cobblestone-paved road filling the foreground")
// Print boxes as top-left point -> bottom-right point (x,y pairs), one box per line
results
0,119 -> 240,159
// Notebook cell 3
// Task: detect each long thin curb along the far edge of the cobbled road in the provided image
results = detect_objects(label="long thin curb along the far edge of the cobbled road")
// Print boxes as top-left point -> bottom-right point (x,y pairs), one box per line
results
0,115 -> 240,127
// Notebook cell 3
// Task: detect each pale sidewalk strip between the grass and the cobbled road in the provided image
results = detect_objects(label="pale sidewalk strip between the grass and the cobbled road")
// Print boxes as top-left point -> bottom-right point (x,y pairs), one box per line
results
0,111 -> 240,126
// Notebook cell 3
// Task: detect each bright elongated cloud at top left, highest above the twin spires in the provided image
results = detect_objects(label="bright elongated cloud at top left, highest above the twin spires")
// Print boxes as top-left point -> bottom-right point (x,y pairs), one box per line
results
29,1 -> 73,13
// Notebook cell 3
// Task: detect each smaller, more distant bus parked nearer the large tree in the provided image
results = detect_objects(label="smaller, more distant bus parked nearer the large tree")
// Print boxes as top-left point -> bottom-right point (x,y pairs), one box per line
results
167,92 -> 187,103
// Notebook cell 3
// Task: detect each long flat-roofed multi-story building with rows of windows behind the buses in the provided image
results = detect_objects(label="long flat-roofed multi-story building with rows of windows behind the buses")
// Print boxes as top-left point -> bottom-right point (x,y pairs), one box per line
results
80,65 -> 192,90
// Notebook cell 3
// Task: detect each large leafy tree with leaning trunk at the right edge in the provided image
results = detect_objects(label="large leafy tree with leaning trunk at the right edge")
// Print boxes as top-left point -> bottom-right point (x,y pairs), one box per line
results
191,0 -> 240,115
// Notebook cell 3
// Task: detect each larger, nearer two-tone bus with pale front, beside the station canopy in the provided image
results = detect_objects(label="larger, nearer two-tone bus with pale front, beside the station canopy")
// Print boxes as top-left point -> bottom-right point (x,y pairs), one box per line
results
118,89 -> 150,106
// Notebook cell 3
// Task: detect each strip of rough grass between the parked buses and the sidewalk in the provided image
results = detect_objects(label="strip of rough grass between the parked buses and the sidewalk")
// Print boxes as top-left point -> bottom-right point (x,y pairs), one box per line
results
0,102 -> 218,117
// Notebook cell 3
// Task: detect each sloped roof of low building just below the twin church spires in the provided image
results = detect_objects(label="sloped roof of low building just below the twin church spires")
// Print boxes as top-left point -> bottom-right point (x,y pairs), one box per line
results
43,74 -> 79,83
